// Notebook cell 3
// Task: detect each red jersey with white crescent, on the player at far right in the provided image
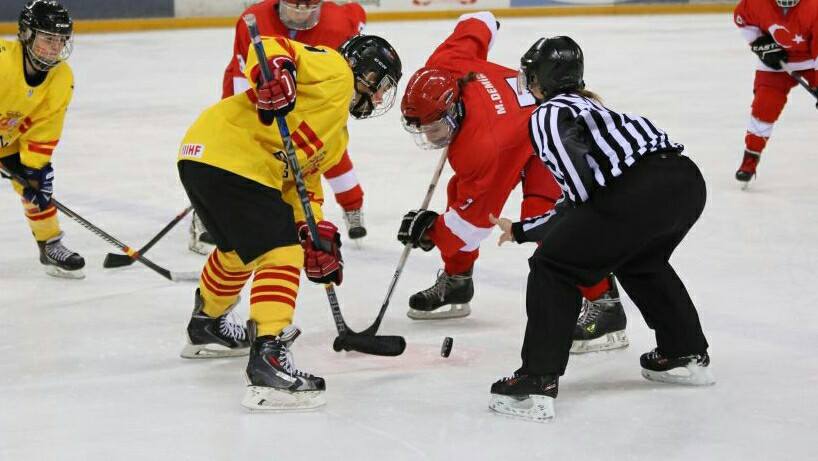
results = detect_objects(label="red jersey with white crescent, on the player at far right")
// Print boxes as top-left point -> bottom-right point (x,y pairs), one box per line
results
733,0 -> 818,72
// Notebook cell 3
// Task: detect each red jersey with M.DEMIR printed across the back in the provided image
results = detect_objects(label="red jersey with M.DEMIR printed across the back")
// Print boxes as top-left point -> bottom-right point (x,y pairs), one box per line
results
418,12 -> 550,257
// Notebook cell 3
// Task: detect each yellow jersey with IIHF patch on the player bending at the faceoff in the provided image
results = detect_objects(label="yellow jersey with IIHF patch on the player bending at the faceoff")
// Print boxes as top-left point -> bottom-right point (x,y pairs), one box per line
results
177,37 -> 354,220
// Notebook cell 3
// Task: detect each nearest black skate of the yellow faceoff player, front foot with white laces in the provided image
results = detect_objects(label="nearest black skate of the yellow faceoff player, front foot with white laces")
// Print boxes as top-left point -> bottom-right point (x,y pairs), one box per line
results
241,325 -> 326,410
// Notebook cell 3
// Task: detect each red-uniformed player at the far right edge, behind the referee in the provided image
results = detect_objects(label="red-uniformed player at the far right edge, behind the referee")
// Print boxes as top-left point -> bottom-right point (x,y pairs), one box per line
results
733,0 -> 818,183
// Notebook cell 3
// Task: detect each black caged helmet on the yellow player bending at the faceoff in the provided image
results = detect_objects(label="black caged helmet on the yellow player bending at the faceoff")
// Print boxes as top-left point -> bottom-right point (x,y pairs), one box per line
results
338,35 -> 402,118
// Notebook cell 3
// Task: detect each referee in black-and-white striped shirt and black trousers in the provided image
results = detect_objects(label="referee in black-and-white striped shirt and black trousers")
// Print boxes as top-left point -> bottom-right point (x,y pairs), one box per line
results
492,37 -> 713,419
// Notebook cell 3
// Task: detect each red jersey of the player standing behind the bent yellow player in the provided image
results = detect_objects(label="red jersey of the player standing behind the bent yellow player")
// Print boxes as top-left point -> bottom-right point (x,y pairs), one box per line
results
222,0 -> 366,99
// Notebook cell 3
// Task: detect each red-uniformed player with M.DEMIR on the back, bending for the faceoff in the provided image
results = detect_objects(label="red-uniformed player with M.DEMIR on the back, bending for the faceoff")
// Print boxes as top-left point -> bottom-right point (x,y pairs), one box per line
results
398,12 -> 627,352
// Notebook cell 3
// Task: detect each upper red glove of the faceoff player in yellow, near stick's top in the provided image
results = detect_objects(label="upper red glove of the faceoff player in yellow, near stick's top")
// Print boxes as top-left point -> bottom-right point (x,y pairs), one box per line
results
253,56 -> 295,126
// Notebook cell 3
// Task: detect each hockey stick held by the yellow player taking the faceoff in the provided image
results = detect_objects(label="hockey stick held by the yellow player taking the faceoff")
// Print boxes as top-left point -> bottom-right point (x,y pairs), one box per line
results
243,14 -> 406,356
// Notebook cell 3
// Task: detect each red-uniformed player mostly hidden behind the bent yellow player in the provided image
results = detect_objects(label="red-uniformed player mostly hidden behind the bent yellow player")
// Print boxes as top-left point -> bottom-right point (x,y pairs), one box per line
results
189,0 -> 366,254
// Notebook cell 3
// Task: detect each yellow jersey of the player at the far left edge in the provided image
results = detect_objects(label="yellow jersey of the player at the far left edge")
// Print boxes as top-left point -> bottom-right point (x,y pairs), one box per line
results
0,39 -> 74,168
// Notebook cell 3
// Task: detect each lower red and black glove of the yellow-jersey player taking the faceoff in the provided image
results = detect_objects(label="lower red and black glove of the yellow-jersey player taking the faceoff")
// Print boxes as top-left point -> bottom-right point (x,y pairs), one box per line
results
298,221 -> 344,285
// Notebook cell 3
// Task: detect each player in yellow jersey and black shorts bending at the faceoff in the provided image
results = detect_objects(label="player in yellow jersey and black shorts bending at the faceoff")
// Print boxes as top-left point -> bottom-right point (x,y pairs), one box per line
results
178,35 -> 401,409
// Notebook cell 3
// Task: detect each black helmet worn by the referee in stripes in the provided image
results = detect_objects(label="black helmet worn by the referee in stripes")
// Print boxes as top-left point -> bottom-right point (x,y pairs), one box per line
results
517,36 -> 585,99
